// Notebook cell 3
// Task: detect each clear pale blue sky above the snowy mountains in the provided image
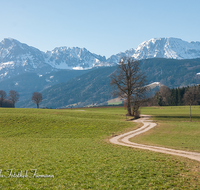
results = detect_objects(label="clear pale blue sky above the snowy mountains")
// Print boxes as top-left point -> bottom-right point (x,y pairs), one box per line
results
0,0 -> 200,58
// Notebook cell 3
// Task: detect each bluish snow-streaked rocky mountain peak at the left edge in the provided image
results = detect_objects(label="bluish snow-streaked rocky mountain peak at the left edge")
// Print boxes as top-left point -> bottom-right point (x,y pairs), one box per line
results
0,38 -> 52,80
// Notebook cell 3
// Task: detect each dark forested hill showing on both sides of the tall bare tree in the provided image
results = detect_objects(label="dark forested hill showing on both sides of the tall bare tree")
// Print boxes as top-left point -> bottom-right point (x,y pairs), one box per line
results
17,58 -> 200,108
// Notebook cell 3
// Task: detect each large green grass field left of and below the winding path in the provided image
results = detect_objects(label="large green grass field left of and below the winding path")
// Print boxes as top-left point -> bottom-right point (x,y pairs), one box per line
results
0,108 -> 200,189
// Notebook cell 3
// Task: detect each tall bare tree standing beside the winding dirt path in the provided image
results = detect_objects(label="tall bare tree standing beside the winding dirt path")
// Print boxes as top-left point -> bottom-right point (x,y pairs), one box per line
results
110,57 -> 147,115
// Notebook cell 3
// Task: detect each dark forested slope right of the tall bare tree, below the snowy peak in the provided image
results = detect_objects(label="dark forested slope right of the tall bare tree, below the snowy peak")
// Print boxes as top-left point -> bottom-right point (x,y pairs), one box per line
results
140,58 -> 200,88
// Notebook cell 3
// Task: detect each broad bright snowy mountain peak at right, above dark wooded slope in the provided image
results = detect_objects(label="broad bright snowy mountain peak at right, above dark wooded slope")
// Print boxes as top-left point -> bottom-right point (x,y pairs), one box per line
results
132,38 -> 200,59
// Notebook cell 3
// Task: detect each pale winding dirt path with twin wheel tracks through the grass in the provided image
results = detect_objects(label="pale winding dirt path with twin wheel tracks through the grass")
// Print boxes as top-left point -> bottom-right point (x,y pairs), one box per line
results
110,115 -> 200,161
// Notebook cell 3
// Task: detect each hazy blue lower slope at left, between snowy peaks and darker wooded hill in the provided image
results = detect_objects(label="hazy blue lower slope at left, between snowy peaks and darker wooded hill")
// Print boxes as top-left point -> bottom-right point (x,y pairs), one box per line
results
0,70 -> 90,101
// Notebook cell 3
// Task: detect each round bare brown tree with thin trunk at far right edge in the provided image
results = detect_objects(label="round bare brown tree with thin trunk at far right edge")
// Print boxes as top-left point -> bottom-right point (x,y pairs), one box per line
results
183,86 -> 200,121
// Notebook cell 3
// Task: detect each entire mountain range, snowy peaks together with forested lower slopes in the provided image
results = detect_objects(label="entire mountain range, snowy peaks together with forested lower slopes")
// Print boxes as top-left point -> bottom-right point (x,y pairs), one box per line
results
0,38 -> 200,107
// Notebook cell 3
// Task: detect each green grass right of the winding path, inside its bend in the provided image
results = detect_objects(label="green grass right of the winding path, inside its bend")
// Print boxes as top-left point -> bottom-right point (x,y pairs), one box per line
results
132,106 -> 200,152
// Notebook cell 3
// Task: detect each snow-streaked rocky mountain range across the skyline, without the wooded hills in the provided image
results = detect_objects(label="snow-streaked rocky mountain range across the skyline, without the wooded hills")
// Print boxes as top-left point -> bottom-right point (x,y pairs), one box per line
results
0,38 -> 200,81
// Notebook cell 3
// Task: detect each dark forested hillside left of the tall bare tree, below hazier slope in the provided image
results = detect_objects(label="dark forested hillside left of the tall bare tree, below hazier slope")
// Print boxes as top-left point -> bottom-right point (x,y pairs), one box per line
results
17,67 -> 116,108
